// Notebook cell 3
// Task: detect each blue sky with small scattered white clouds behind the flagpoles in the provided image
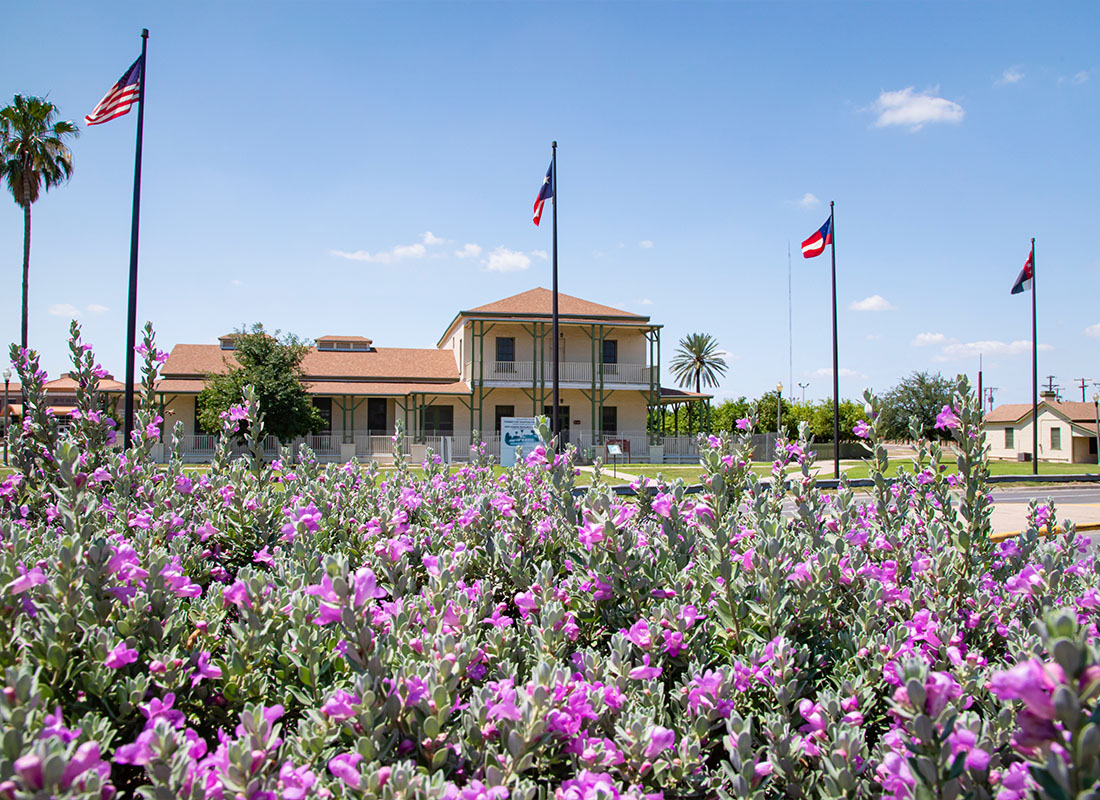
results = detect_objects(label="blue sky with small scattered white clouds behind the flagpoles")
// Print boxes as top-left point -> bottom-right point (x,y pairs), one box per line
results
0,1 -> 1100,403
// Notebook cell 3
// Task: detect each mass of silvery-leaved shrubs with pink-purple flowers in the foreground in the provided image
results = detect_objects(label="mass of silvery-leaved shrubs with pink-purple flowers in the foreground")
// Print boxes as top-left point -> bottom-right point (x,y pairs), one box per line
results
0,330 -> 1100,800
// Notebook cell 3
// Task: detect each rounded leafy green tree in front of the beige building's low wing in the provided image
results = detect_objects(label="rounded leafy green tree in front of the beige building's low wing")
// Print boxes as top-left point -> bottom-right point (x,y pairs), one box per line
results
198,324 -> 325,442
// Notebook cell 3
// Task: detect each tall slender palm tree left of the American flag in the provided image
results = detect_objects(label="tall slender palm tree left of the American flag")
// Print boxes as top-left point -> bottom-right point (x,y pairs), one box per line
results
0,95 -> 80,349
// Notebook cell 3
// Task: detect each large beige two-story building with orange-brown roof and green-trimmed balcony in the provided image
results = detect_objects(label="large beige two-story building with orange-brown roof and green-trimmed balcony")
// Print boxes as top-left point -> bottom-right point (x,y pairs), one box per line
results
157,288 -> 710,462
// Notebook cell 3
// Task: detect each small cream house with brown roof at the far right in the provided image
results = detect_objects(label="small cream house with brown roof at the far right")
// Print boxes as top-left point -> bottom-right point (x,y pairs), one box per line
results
985,396 -> 1097,464
